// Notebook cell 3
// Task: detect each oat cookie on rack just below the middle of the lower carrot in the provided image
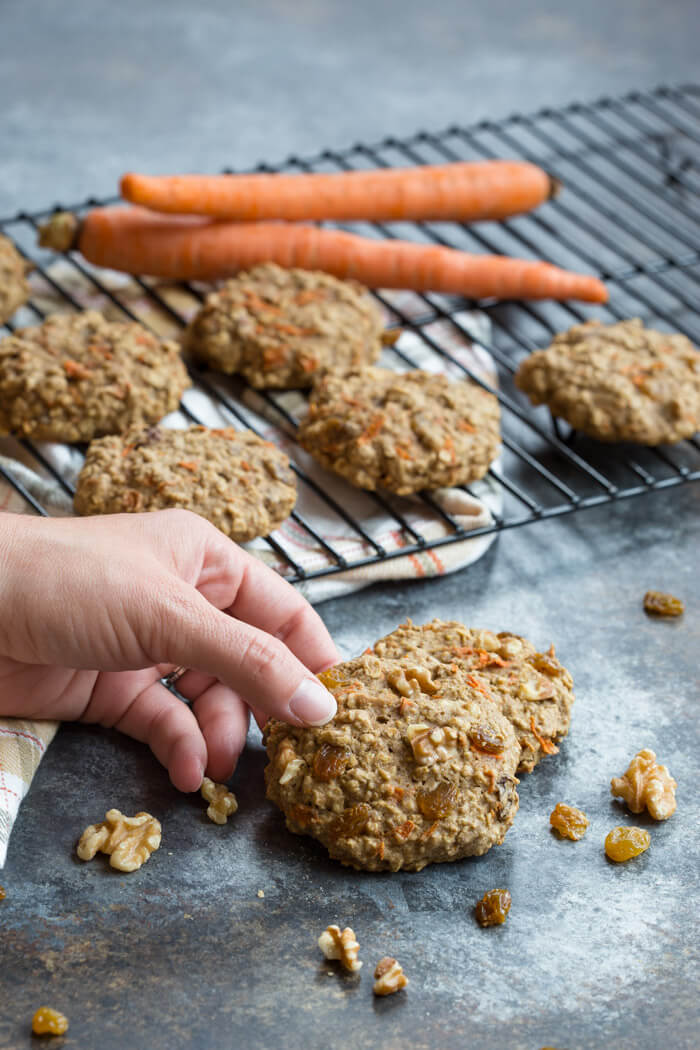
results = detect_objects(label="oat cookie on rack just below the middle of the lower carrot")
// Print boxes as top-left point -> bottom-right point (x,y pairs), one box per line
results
183,263 -> 384,390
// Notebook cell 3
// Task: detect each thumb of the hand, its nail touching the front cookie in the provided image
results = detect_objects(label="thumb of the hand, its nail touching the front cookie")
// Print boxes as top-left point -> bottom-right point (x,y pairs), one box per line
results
150,584 -> 337,726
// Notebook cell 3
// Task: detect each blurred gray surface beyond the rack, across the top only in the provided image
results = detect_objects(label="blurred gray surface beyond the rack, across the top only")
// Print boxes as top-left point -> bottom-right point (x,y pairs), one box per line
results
0,0 -> 700,214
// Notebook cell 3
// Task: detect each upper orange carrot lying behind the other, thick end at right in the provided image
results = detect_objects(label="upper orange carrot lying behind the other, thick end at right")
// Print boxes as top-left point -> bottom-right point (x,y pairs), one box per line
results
120,161 -> 559,223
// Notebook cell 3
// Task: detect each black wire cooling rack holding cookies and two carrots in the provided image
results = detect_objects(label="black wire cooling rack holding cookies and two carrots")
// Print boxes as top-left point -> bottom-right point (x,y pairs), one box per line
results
0,85 -> 700,582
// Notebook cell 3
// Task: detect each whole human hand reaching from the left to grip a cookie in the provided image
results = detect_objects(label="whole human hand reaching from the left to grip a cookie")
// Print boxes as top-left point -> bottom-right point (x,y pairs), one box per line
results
0,510 -> 339,791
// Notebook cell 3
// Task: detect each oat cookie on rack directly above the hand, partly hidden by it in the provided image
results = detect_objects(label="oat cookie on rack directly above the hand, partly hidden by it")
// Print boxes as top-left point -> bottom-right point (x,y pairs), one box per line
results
75,425 -> 297,543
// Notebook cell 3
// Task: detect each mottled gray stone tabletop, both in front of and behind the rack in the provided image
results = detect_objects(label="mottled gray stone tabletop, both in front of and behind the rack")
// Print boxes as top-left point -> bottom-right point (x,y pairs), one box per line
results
0,0 -> 700,1050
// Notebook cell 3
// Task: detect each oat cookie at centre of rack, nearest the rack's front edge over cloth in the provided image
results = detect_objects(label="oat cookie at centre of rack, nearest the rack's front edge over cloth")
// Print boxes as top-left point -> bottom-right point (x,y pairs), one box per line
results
299,365 -> 501,496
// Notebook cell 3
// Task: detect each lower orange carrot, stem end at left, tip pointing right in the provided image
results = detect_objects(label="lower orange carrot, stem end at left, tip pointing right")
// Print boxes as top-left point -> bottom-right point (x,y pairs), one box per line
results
36,207 -> 608,302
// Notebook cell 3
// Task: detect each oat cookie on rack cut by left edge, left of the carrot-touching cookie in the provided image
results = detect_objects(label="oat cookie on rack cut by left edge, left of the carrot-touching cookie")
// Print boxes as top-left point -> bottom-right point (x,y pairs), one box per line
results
0,310 -> 190,441
